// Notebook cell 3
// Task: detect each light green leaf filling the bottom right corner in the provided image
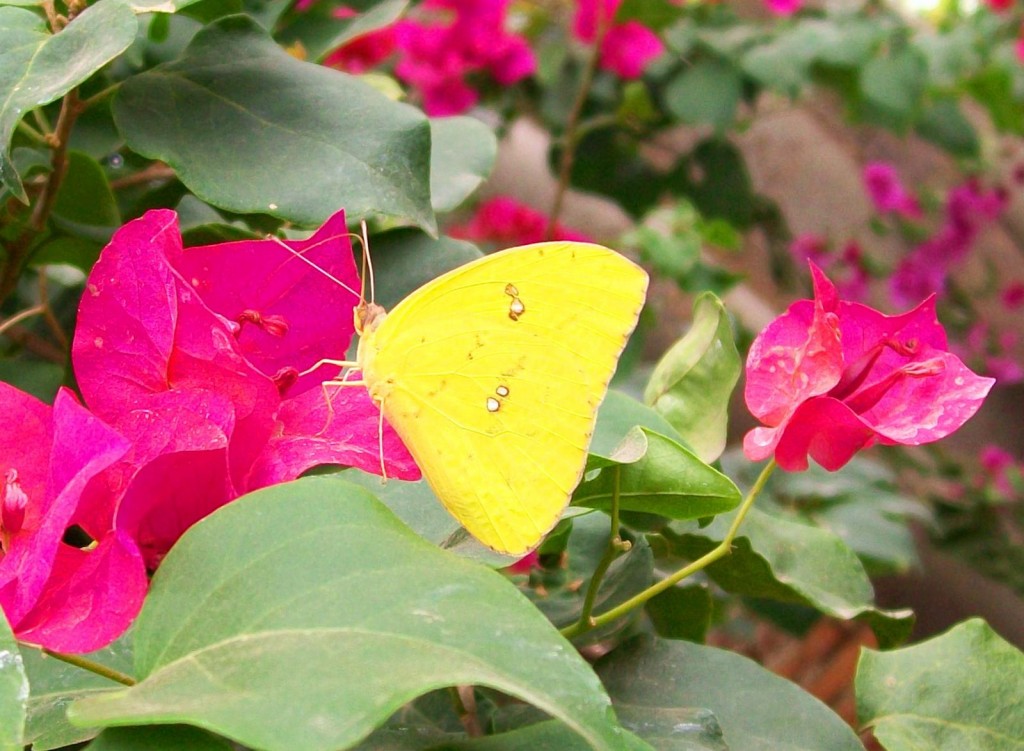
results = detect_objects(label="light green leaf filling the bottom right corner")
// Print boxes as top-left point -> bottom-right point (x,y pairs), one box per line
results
856,618 -> 1024,751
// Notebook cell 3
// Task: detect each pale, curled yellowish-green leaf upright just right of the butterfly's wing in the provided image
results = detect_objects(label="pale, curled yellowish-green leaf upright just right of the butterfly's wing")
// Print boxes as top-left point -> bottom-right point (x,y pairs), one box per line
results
643,292 -> 742,462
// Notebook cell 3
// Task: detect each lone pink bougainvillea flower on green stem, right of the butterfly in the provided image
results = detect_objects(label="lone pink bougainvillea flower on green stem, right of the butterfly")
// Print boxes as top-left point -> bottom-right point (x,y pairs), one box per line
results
743,264 -> 993,470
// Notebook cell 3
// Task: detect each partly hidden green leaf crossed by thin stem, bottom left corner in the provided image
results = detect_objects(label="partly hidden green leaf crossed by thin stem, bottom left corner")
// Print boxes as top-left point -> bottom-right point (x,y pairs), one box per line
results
22,636 -> 132,751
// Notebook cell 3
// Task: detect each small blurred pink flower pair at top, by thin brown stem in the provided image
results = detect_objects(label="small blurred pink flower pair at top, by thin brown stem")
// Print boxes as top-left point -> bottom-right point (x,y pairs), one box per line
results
572,0 -> 665,79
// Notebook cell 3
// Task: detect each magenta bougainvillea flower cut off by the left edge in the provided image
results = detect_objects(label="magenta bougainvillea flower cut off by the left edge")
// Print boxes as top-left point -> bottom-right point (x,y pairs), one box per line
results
0,383 -> 146,653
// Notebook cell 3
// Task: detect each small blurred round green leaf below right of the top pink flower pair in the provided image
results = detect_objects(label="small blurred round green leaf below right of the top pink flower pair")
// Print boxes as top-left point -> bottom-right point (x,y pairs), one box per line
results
665,59 -> 742,131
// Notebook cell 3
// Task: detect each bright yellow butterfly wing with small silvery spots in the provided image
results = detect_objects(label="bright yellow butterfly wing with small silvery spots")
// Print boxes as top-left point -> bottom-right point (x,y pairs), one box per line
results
360,243 -> 647,553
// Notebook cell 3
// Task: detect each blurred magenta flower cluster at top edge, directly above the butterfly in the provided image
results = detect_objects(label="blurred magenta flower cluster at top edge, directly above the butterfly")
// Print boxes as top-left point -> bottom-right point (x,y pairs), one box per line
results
394,0 -> 537,116
